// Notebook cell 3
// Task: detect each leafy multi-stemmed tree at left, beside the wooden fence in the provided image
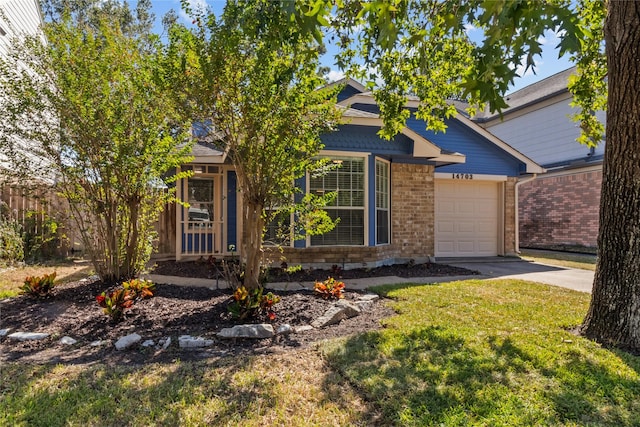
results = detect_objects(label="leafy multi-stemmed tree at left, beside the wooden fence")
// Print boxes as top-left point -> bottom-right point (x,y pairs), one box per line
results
0,2 -> 189,282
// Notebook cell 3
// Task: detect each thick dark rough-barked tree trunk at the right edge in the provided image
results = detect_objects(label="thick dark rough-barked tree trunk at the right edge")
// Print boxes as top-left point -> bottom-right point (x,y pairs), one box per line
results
582,0 -> 640,351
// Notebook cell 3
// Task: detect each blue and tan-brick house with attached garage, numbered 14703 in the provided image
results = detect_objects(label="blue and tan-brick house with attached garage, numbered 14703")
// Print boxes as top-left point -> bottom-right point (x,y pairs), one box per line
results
159,80 -> 543,268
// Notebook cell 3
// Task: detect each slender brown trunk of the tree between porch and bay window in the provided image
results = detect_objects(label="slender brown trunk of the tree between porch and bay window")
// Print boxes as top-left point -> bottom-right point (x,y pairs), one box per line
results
242,198 -> 264,289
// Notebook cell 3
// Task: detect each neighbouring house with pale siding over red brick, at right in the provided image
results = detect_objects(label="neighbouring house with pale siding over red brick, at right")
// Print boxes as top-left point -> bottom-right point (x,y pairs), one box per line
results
474,68 -> 605,248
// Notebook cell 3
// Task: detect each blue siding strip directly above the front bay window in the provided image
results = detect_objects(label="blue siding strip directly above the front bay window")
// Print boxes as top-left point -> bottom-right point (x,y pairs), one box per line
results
320,125 -> 413,155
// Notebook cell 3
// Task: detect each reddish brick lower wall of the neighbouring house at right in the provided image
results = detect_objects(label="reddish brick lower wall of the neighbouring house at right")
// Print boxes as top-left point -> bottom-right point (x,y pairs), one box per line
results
518,171 -> 602,247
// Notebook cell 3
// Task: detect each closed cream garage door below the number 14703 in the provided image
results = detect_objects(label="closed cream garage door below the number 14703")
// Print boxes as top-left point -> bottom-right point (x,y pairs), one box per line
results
435,179 -> 499,257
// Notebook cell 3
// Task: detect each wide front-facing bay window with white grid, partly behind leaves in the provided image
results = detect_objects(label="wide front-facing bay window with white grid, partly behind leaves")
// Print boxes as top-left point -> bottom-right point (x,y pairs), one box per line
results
309,157 -> 365,246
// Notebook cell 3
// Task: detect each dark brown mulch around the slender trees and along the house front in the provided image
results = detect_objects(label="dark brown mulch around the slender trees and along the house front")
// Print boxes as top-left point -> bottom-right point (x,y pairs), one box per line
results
0,263 -> 472,364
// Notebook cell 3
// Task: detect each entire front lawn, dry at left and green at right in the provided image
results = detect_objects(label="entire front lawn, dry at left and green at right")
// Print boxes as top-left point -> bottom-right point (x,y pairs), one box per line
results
0,280 -> 640,426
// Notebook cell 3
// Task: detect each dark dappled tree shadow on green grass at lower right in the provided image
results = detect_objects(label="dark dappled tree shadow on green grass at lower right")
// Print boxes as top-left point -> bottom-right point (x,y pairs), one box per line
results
323,326 -> 640,426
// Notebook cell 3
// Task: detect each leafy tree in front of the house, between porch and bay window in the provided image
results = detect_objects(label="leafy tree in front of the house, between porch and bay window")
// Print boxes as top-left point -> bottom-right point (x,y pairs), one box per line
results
170,0 -> 340,288
